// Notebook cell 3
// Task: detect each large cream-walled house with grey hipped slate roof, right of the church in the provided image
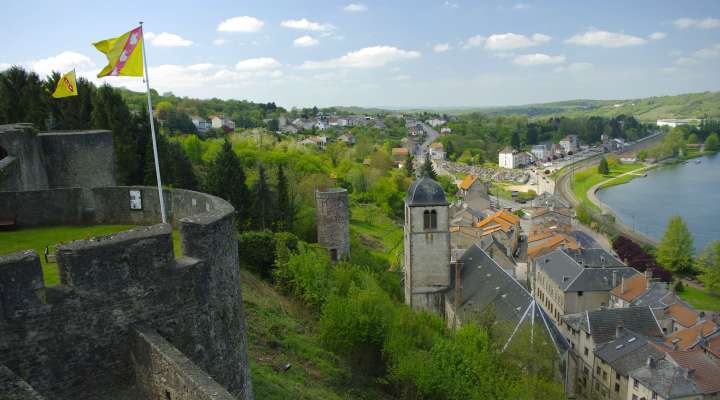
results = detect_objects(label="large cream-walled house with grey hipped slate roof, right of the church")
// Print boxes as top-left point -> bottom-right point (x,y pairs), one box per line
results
530,249 -> 638,323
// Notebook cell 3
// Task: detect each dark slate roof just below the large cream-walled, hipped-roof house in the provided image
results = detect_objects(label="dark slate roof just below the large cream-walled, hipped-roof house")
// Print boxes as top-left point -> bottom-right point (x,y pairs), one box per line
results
562,307 -> 663,344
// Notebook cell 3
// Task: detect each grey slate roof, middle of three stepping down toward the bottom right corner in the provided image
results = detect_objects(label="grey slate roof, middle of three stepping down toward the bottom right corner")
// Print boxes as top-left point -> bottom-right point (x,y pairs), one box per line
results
595,329 -> 664,376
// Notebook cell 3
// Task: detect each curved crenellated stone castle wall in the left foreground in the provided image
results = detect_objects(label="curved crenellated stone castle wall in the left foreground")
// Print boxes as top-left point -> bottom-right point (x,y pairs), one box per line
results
0,187 -> 252,399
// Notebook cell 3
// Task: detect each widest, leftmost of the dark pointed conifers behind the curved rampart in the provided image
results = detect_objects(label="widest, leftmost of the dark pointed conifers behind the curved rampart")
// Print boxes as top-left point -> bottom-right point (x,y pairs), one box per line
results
205,139 -> 250,230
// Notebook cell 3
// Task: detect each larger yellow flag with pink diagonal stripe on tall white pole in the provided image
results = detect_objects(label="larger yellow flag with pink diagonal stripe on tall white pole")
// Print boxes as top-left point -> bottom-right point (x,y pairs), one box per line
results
93,26 -> 143,78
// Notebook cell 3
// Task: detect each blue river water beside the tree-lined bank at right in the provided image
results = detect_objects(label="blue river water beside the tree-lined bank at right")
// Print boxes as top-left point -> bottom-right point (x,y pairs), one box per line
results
597,154 -> 720,253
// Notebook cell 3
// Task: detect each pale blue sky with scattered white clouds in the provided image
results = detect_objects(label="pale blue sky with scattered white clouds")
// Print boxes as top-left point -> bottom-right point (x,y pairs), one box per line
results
0,0 -> 720,108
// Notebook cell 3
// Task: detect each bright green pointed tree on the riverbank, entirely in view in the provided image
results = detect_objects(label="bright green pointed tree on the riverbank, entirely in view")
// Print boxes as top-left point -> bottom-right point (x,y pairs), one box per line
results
656,215 -> 694,273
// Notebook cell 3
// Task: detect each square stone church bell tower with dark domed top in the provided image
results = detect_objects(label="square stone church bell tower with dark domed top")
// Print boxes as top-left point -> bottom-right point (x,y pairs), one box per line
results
404,177 -> 450,314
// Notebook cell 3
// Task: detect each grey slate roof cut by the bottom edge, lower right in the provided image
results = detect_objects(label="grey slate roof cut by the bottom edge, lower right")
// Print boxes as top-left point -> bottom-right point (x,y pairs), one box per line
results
630,360 -> 702,400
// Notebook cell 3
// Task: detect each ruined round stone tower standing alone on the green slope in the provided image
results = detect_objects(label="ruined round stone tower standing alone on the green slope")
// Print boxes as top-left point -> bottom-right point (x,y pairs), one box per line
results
315,188 -> 350,261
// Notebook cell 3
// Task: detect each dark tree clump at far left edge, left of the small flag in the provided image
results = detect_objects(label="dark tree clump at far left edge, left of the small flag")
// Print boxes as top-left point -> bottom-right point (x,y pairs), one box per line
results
0,67 -> 49,130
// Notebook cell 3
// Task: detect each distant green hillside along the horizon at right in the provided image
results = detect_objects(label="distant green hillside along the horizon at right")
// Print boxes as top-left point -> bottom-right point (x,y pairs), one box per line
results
428,92 -> 720,122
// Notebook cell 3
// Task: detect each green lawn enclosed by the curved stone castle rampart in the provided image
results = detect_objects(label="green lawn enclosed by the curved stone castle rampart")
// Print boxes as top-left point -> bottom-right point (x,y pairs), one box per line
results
0,225 -> 180,286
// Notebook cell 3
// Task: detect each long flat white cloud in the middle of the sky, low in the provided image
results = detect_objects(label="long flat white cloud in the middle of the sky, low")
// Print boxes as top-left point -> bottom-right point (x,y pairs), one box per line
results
300,46 -> 420,69
